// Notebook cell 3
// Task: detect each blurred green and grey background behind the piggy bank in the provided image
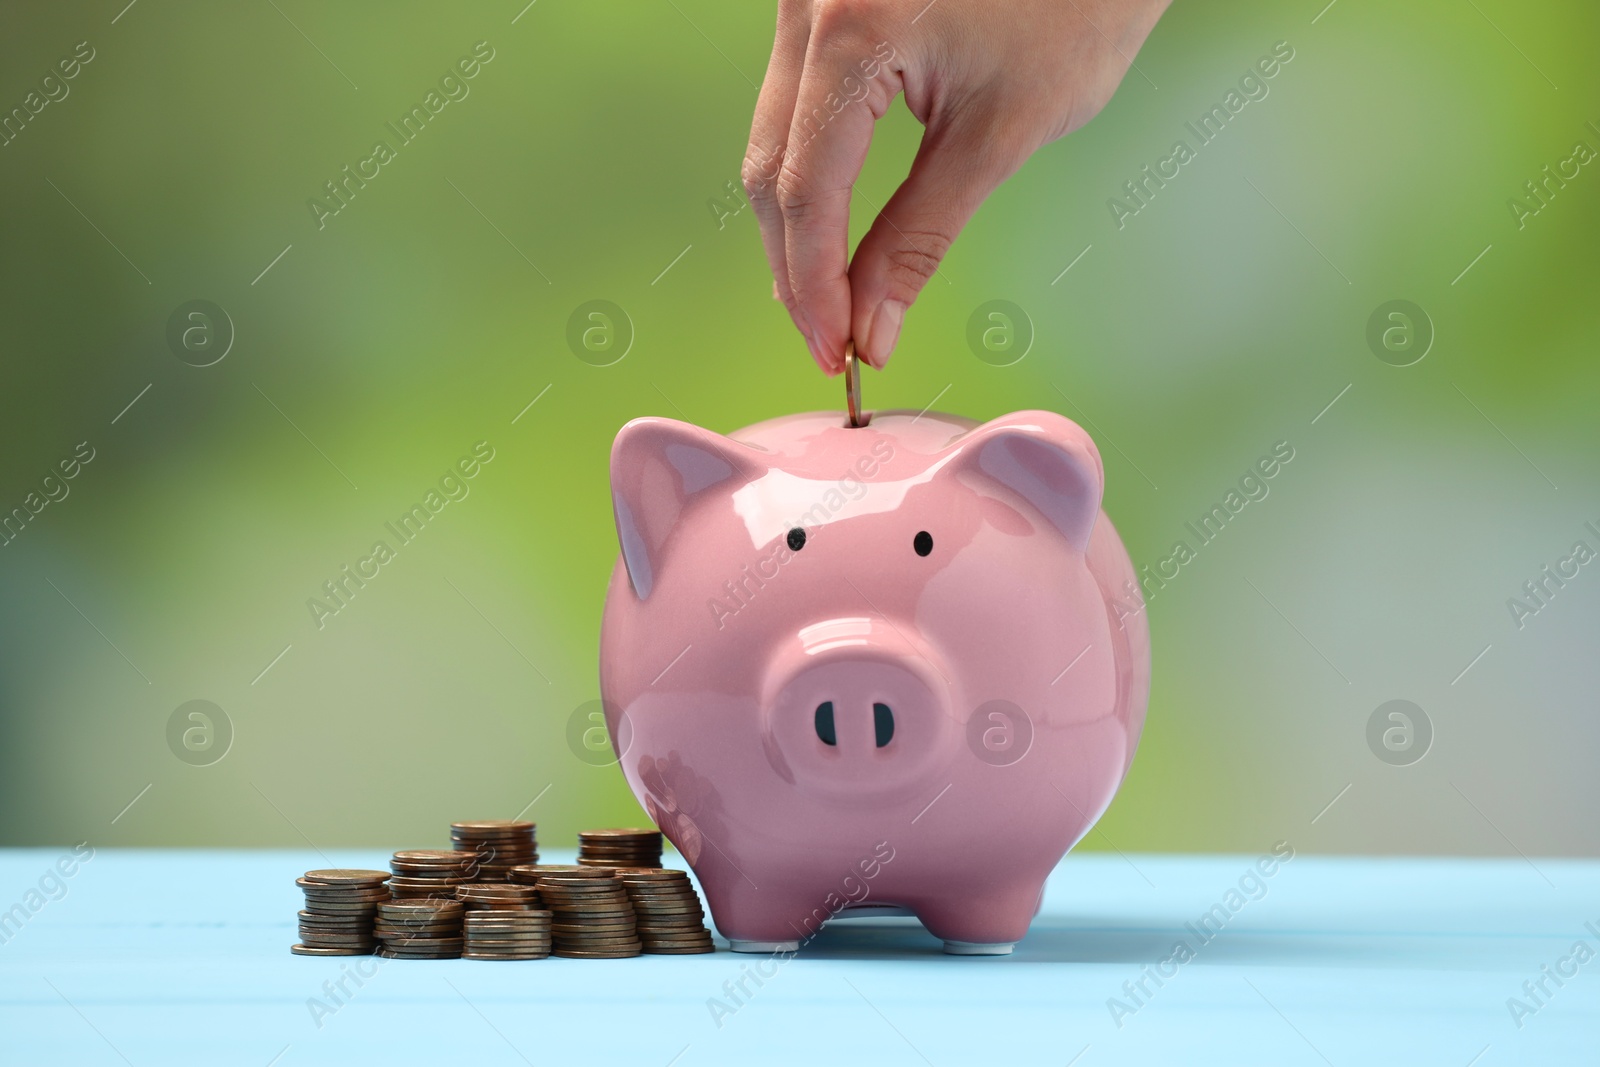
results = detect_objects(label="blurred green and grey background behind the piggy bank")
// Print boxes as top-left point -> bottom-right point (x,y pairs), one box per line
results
0,0 -> 1600,854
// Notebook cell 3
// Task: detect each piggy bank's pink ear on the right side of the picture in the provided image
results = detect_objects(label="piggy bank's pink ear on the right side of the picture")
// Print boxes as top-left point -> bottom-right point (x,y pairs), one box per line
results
950,411 -> 1106,552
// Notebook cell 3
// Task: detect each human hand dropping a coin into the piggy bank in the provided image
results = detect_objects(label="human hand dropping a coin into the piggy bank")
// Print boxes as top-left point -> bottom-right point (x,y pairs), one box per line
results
742,0 -> 1171,374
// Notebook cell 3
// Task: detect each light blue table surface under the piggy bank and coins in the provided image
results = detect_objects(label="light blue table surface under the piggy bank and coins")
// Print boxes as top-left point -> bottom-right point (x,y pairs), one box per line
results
0,849 -> 1600,1067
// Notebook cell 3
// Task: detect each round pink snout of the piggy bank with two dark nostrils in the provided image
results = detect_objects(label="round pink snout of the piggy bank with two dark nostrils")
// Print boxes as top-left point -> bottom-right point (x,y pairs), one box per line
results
763,619 -> 950,797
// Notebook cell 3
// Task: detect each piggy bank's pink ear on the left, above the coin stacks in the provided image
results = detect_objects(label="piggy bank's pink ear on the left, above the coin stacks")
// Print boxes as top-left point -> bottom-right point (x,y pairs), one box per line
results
611,419 -> 766,600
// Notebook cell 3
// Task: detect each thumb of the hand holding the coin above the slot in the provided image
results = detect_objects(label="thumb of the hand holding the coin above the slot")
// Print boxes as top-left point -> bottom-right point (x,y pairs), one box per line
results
850,117 -> 1027,370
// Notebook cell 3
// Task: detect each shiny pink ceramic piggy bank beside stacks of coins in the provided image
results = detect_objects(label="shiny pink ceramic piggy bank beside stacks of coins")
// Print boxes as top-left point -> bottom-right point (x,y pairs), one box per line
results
600,411 -> 1150,955
